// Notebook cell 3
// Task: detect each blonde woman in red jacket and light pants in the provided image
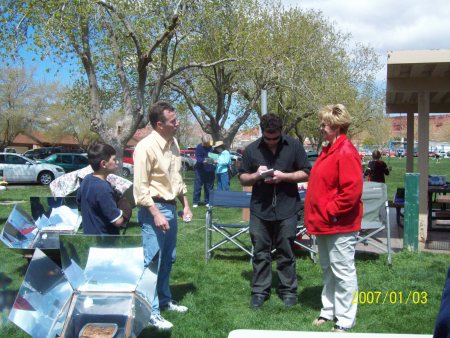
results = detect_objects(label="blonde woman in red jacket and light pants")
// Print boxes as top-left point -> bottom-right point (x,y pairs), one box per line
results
305,104 -> 363,332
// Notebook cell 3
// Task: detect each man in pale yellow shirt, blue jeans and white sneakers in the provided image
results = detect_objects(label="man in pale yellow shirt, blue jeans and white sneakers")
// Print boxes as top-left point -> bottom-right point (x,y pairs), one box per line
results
133,101 -> 192,330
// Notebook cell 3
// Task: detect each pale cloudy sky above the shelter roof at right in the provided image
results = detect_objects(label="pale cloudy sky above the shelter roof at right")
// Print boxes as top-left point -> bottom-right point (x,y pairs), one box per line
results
281,0 -> 450,80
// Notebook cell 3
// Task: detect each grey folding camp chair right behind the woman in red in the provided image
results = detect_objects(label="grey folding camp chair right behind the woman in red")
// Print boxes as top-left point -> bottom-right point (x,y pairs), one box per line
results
357,182 -> 392,266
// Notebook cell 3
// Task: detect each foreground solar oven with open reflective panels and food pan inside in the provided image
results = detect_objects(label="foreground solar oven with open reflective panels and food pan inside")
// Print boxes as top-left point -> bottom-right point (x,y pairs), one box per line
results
10,235 -> 157,338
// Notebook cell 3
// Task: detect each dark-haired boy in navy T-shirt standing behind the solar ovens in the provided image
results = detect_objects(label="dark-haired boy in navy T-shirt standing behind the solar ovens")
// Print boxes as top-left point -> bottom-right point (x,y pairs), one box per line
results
77,143 -> 131,235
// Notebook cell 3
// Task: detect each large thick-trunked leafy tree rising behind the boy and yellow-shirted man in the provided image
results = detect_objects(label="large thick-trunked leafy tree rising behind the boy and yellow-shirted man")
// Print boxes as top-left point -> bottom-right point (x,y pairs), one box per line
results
0,0 -> 232,157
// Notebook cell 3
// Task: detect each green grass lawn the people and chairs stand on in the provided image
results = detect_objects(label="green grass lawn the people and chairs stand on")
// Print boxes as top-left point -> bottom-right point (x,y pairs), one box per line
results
0,163 -> 450,338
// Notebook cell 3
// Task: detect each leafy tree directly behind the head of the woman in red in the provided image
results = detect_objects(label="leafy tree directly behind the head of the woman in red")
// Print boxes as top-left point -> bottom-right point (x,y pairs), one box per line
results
269,8 -> 383,147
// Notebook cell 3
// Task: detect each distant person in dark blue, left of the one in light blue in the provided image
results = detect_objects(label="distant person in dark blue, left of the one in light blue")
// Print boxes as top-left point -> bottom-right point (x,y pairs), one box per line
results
192,135 -> 215,208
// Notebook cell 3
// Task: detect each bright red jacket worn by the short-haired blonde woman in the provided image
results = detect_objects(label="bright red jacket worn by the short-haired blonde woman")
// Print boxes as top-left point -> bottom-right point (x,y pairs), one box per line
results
305,134 -> 363,235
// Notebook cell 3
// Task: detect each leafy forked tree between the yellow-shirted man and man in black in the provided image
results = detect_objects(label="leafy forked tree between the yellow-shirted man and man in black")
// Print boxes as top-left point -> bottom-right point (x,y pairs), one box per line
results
169,0 -> 259,144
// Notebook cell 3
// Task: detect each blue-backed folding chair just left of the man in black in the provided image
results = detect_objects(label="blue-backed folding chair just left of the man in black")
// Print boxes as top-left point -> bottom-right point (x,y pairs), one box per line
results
205,190 -> 253,262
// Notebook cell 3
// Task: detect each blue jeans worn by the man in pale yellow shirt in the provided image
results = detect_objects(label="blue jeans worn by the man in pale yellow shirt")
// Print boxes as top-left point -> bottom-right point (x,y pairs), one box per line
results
138,203 -> 177,315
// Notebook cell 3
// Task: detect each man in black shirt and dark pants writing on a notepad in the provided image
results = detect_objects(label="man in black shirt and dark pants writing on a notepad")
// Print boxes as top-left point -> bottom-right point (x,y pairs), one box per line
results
239,114 -> 311,308
